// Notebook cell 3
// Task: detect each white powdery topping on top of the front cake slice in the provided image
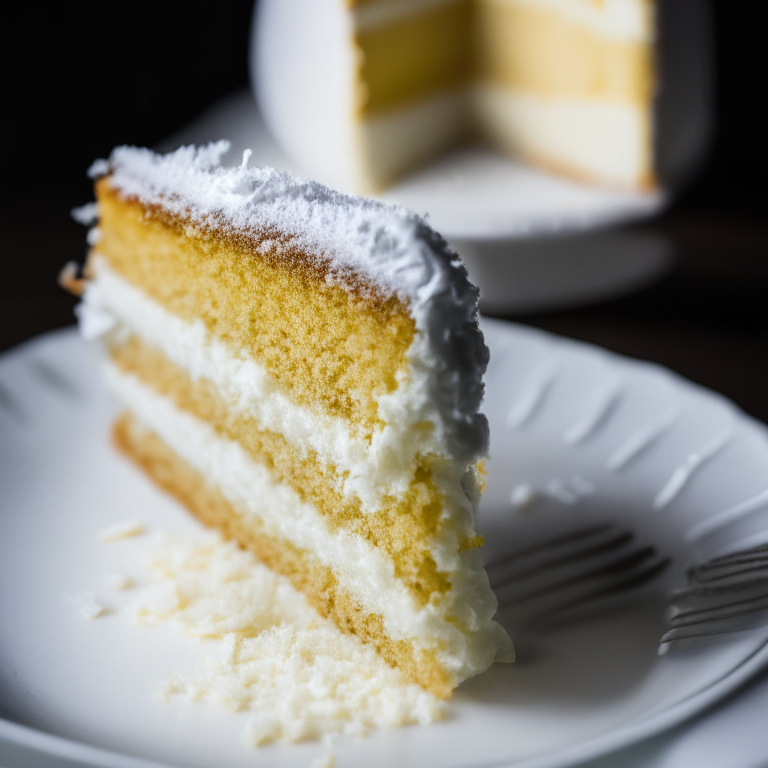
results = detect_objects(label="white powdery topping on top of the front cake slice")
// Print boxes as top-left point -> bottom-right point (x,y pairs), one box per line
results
97,141 -> 474,305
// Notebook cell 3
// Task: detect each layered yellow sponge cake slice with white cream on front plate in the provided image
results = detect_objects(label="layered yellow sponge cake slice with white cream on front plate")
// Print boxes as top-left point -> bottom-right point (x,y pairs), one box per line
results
75,142 -> 512,696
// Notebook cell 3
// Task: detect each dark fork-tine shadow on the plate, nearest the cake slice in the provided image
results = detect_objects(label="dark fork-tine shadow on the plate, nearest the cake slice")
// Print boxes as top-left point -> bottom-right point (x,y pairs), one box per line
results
486,523 -> 670,630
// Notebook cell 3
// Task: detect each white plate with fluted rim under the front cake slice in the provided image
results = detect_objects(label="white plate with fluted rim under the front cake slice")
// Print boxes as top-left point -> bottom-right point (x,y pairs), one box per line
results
0,321 -> 768,768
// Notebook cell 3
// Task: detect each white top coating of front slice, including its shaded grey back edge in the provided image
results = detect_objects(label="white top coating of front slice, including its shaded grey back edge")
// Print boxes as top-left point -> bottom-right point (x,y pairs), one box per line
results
89,141 -> 489,463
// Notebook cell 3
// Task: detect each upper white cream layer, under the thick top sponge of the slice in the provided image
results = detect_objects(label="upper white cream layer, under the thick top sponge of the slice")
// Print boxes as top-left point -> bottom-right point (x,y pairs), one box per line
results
84,254 -> 473,512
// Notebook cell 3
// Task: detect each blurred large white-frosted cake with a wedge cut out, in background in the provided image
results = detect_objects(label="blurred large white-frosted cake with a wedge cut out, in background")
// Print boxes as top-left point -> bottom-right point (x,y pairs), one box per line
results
255,0 -> 657,193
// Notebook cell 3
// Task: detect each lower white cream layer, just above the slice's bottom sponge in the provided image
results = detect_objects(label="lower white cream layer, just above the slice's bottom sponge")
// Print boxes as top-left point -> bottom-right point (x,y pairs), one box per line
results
105,363 -> 510,679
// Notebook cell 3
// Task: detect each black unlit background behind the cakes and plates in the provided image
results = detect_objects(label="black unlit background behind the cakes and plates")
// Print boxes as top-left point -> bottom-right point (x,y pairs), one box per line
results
0,0 -> 768,421
